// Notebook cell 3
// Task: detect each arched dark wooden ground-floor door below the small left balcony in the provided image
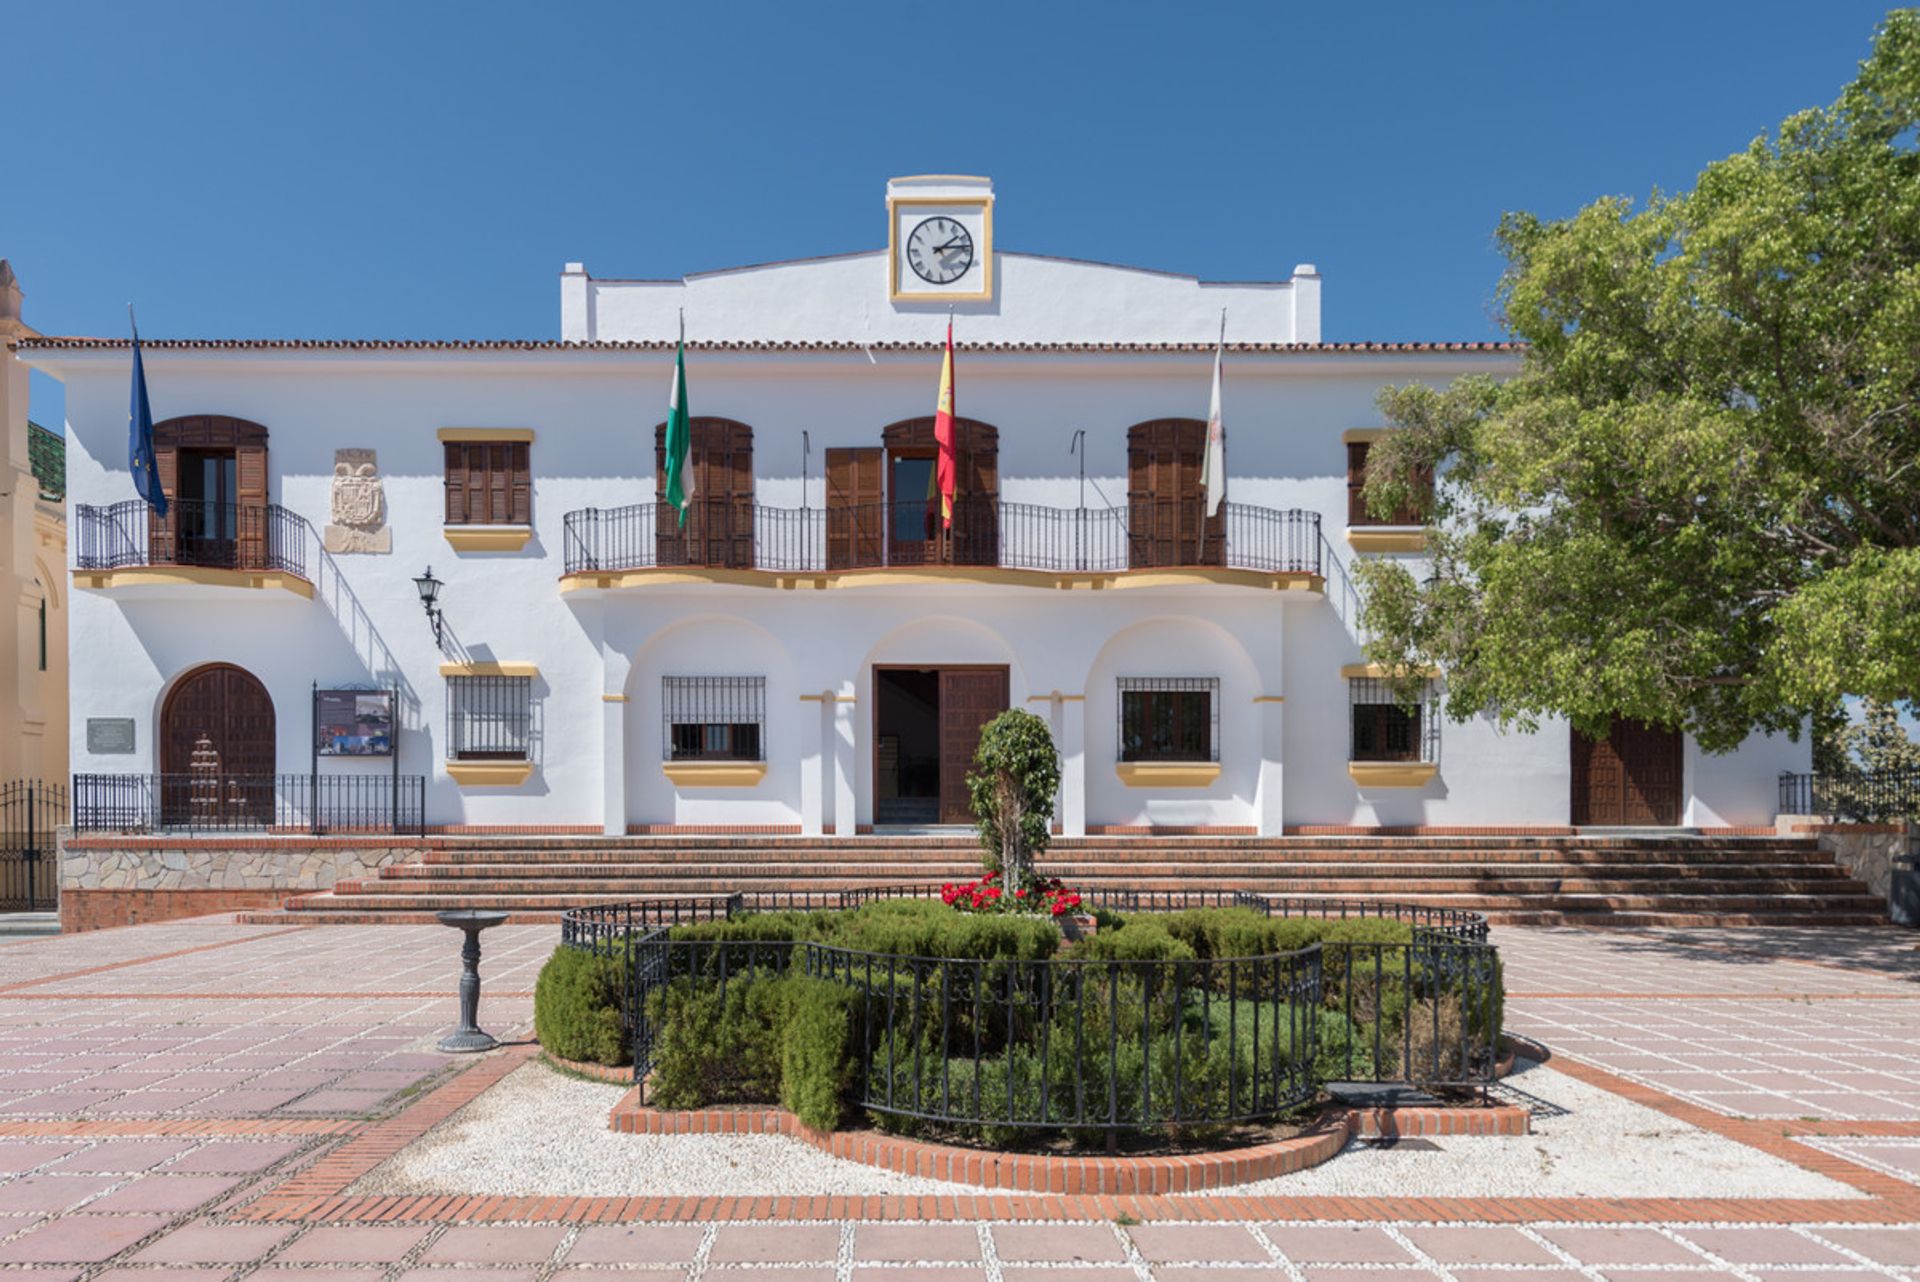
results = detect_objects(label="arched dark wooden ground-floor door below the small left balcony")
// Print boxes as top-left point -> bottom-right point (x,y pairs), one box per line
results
159,664 -> 275,827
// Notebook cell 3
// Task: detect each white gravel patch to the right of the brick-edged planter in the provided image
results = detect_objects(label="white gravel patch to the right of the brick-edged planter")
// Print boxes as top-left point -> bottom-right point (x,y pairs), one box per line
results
1235,1059 -> 1864,1199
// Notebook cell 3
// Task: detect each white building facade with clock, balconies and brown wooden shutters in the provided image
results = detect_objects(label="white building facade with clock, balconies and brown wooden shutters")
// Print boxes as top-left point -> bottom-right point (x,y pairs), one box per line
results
19,178 -> 1809,835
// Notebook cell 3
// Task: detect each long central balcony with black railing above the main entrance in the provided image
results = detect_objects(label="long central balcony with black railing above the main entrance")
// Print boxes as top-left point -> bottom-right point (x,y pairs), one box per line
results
564,499 -> 1321,591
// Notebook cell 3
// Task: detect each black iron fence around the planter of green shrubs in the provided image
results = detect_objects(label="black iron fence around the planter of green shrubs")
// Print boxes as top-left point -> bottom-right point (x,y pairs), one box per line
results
561,883 -> 1503,1138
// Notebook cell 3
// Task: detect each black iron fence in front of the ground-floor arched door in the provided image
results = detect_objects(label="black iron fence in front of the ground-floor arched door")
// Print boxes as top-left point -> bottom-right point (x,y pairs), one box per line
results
73,773 -> 426,835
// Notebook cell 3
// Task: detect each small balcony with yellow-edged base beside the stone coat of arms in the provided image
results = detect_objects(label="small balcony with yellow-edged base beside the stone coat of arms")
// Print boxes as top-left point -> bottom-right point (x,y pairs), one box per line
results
73,499 -> 313,597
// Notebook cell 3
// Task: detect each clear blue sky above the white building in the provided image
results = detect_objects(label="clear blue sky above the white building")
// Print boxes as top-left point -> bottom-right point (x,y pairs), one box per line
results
0,0 -> 1885,424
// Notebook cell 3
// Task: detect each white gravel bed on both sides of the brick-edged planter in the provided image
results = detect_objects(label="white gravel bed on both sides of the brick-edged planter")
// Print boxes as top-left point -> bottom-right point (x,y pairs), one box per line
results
349,1061 -> 1860,1199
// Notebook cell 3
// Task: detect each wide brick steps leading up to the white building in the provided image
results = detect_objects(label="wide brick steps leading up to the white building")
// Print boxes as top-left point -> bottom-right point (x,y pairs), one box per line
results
240,835 -> 1885,927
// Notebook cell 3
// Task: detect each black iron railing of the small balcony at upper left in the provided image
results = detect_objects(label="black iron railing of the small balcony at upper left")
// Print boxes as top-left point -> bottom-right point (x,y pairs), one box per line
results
71,499 -> 313,578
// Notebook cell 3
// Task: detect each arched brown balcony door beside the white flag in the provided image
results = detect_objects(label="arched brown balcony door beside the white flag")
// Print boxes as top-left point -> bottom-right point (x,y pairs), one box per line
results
1127,418 -> 1227,570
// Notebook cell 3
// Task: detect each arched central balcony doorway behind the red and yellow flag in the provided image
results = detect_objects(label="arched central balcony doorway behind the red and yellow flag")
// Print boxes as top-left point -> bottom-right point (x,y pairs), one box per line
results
879,416 -> 1000,566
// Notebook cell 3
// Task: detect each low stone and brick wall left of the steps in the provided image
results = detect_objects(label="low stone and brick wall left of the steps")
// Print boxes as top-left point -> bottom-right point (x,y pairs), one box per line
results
60,833 -> 424,931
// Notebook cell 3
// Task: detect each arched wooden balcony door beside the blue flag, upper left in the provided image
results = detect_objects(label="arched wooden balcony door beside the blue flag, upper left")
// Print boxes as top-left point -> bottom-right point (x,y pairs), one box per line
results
148,415 -> 267,570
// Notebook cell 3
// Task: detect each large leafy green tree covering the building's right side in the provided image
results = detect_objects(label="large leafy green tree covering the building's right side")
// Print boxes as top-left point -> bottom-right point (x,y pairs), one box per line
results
1359,10 -> 1920,750
